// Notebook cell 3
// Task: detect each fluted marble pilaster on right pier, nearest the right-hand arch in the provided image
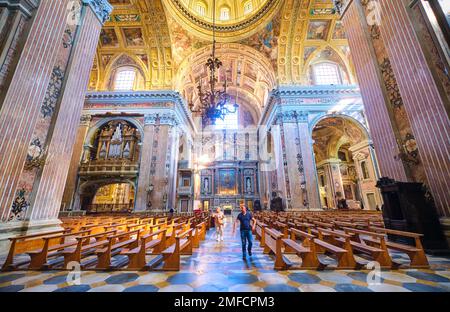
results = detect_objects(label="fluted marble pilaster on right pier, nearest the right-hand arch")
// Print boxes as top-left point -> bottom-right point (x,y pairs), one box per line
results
342,0 -> 408,181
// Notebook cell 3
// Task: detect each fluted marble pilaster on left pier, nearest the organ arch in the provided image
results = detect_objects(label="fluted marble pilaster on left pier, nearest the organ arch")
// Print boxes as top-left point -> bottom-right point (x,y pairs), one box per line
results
30,0 -> 111,220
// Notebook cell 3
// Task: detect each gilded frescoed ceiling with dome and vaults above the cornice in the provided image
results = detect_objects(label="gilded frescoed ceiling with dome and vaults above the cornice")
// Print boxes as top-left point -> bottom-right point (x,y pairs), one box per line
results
89,0 -> 355,110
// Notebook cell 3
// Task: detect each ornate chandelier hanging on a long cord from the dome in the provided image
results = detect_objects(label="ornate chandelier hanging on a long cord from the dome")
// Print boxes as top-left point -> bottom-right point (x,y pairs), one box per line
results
189,0 -> 239,126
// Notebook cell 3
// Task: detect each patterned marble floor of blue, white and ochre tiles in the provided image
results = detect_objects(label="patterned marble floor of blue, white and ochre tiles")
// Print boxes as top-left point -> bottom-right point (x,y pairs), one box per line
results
0,218 -> 450,292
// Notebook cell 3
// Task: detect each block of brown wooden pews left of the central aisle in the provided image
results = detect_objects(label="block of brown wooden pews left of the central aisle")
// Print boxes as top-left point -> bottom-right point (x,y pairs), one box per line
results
2,215 -> 209,271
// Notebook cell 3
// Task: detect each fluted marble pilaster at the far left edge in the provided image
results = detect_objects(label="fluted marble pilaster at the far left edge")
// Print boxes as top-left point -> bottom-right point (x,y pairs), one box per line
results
0,0 -> 73,220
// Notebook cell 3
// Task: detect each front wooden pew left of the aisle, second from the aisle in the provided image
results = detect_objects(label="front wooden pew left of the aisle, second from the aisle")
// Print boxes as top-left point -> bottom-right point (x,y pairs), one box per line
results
120,229 -> 167,270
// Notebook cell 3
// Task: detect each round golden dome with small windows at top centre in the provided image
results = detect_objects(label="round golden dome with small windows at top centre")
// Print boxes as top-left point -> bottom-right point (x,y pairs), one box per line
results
162,0 -> 283,42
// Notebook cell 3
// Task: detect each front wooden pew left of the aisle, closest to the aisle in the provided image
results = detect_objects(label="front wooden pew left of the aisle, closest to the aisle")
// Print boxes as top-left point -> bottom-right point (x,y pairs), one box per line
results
161,229 -> 192,271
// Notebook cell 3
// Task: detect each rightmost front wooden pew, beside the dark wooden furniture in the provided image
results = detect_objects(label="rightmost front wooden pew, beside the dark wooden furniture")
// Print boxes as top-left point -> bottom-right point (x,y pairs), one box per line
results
364,227 -> 430,268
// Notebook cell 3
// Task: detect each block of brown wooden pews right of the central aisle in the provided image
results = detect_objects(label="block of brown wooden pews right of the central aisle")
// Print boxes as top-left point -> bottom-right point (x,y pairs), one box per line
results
255,212 -> 429,270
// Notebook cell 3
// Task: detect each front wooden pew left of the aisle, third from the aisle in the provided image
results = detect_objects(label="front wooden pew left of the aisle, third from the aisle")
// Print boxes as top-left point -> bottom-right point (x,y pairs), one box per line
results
95,230 -> 140,270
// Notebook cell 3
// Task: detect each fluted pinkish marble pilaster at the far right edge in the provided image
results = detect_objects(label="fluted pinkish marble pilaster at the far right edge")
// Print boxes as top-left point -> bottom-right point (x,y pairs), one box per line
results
379,0 -> 450,218
